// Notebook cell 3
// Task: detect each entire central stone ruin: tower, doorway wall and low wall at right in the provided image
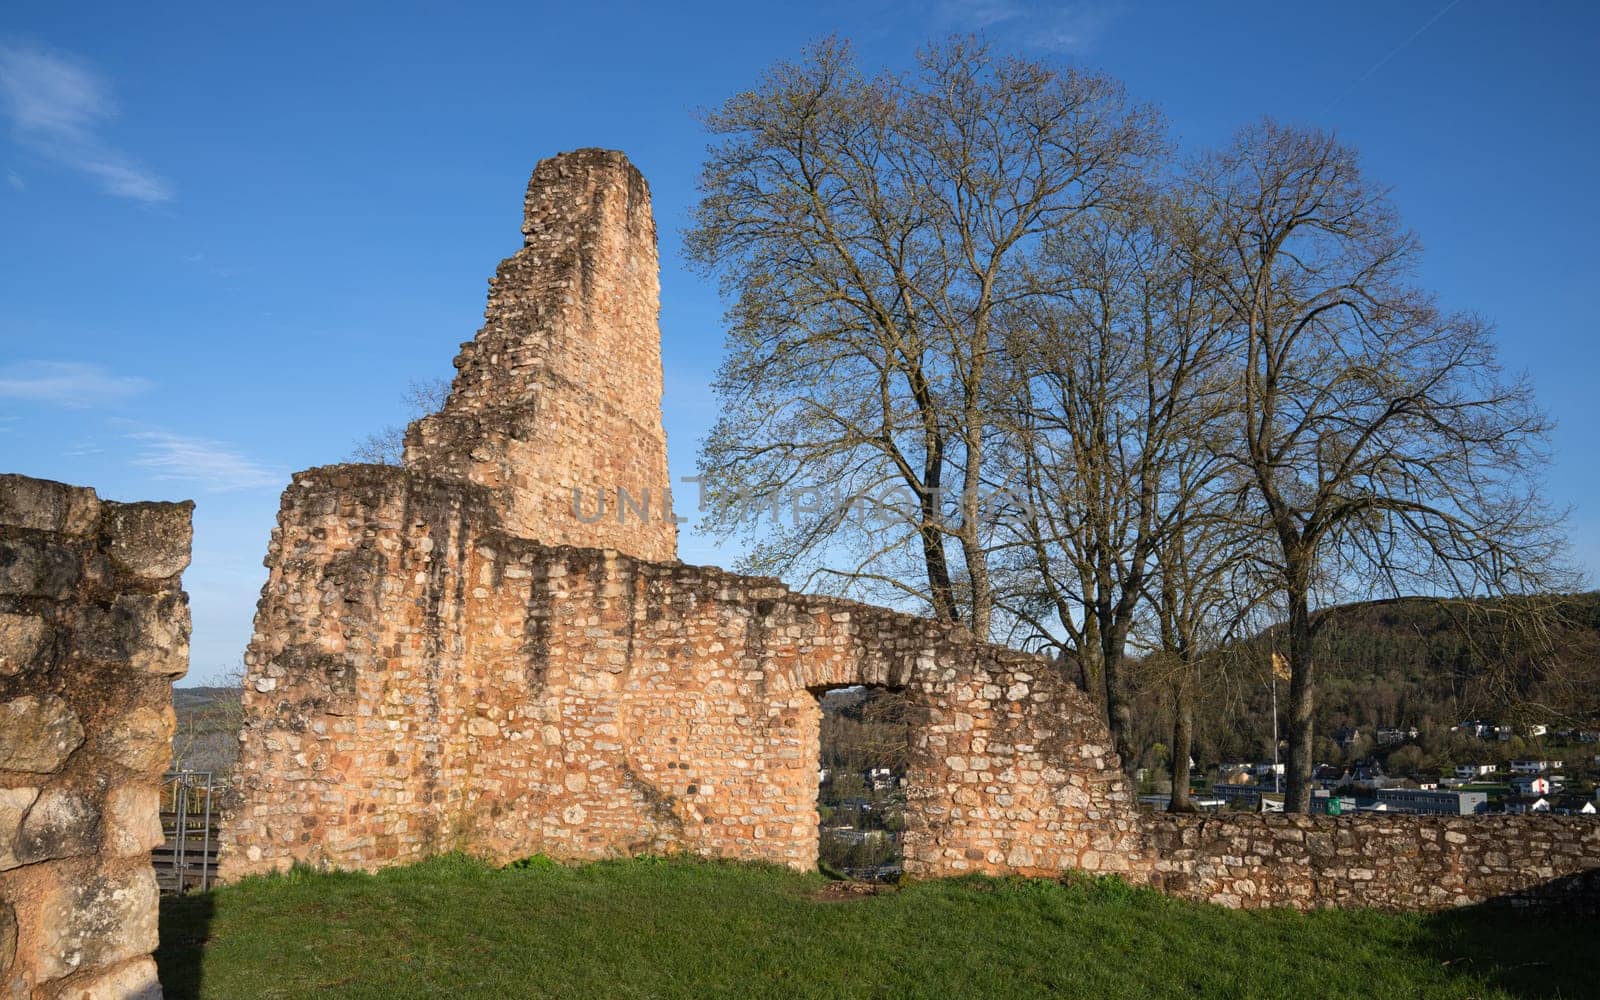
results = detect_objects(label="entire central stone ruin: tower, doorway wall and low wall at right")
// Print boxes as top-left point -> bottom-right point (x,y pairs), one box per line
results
222,150 -> 1600,909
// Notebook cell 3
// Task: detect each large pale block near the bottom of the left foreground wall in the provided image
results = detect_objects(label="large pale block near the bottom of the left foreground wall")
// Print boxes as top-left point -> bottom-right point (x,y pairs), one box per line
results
38,864 -> 158,979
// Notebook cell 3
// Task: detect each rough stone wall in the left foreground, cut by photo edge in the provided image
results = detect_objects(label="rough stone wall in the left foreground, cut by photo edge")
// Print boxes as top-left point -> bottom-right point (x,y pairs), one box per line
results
0,475 -> 194,1000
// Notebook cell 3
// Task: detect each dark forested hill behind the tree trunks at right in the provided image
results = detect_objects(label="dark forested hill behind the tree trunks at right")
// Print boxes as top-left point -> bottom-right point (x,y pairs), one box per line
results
1136,592 -> 1600,762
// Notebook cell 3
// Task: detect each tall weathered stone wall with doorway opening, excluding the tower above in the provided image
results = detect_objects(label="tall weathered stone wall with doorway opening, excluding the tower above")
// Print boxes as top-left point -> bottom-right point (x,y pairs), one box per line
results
224,466 -> 1139,878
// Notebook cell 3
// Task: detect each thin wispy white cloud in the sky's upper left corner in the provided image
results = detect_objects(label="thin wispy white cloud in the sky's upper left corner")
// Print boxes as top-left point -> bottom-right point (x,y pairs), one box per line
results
0,45 -> 173,202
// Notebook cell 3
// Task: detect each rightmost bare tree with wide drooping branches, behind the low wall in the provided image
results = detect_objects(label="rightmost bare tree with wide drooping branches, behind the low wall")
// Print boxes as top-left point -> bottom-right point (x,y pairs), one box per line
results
1194,122 -> 1560,811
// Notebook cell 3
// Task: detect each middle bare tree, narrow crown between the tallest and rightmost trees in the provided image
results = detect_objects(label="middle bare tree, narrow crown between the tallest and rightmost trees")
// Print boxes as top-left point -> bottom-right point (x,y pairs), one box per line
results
995,197 -> 1237,757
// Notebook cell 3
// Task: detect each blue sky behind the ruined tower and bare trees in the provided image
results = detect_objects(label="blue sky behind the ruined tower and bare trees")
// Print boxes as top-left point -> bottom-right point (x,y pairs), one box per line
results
0,0 -> 1600,683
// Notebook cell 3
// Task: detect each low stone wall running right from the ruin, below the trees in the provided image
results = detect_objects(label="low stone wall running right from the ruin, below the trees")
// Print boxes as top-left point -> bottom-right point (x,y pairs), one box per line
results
1144,813 -> 1600,912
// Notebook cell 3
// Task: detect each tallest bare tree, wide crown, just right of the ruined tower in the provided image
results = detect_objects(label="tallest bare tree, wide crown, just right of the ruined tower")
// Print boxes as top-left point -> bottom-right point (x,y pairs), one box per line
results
688,40 -> 1160,637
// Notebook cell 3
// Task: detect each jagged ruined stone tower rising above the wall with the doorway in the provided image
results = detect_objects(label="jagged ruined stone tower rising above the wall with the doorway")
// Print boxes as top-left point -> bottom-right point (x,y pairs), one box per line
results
405,149 -> 677,562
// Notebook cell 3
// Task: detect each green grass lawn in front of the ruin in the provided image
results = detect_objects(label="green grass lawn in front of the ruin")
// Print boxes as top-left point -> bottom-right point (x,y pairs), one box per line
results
157,856 -> 1600,1000
